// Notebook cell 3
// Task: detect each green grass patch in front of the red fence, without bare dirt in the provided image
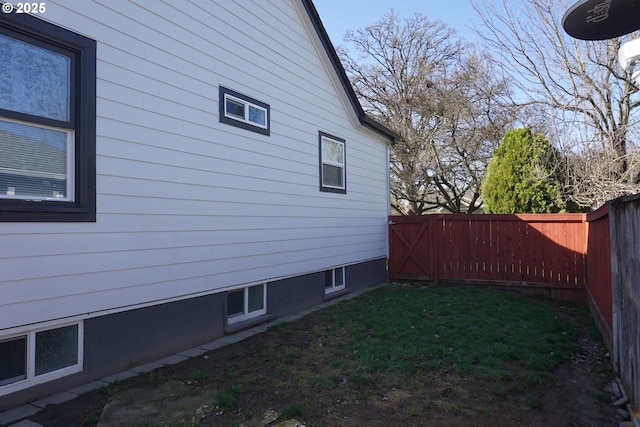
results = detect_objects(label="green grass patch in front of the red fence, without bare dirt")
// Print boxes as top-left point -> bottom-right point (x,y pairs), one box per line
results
279,286 -> 588,406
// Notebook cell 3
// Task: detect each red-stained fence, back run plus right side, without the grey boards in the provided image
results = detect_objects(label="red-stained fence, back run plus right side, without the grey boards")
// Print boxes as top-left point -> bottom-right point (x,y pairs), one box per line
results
389,212 -> 613,336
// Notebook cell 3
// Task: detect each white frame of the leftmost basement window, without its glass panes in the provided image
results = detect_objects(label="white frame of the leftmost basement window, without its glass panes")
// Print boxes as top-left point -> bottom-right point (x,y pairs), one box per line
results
0,321 -> 84,396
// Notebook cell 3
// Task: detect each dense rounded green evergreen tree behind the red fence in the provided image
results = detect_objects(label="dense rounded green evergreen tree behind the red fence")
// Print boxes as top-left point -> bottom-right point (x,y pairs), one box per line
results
482,128 -> 563,214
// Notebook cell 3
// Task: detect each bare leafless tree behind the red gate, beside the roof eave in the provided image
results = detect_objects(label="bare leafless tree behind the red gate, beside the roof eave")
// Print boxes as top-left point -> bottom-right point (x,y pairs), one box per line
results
338,11 -> 514,214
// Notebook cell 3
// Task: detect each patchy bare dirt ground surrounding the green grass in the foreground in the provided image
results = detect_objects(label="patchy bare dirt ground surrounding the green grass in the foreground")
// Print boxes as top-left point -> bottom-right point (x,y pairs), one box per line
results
30,288 -> 618,427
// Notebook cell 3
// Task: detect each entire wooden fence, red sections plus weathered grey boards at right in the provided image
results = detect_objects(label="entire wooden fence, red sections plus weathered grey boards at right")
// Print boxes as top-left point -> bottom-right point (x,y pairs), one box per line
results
389,200 -> 640,413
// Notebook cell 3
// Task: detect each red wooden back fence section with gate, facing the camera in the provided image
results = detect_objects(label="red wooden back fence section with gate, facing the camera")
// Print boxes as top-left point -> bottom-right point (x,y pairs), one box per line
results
389,214 -> 588,289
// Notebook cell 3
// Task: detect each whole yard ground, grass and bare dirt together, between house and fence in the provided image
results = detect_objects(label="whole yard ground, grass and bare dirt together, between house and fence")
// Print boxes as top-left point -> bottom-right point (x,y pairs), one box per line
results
36,284 -> 613,427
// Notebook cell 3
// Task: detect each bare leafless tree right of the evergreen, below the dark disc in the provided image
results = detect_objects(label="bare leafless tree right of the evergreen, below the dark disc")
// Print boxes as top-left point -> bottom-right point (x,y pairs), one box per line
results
473,0 -> 640,207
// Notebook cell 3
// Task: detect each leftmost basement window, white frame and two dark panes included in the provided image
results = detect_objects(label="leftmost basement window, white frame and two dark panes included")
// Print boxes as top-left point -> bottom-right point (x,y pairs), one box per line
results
0,323 -> 83,394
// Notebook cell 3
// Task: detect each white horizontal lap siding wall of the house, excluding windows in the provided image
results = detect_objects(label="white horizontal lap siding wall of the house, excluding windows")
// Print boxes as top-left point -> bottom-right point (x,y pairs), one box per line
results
0,0 -> 387,334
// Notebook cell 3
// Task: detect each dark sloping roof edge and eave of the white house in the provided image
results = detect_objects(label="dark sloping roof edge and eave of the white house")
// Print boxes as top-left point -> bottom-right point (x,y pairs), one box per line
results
301,0 -> 399,144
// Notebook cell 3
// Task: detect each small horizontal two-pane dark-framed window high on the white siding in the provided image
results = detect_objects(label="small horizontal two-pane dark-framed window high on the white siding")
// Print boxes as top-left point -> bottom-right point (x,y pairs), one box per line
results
219,86 -> 270,136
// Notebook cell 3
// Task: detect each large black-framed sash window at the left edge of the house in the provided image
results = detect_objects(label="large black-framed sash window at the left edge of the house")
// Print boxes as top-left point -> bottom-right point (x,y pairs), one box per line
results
0,12 -> 96,222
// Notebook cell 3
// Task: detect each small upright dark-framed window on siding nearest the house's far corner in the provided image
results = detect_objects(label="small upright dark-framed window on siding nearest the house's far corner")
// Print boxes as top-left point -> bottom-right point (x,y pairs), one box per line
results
319,132 -> 347,193
